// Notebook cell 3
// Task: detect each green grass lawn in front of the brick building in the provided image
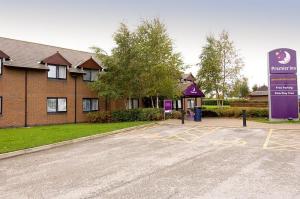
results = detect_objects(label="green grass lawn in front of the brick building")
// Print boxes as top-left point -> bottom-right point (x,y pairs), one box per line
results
0,122 -> 149,154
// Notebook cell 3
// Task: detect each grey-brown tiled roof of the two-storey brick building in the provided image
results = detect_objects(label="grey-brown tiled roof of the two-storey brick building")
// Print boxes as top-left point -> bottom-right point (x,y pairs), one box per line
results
0,37 -> 101,70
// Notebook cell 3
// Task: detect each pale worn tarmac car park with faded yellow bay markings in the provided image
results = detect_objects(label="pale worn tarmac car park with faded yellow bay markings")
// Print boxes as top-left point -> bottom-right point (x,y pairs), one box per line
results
0,122 -> 300,199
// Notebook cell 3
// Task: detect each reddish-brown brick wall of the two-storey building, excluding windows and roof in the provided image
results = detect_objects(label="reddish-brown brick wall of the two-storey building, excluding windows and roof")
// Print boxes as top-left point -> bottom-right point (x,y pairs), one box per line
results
0,67 -> 124,128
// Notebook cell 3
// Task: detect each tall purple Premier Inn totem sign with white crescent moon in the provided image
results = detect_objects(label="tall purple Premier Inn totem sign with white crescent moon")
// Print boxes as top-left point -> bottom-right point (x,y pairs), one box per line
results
269,48 -> 299,119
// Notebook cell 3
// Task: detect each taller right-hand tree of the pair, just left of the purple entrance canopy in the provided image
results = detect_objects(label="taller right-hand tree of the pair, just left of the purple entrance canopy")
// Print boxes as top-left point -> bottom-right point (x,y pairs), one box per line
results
136,19 -> 183,108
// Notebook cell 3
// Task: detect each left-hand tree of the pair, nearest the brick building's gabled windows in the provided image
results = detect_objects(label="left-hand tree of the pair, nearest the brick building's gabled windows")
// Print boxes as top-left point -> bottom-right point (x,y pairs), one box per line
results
91,24 -> 141,108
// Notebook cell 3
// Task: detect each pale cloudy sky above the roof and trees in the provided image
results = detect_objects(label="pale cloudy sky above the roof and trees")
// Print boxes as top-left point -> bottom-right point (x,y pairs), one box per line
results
0,0 -> 300,86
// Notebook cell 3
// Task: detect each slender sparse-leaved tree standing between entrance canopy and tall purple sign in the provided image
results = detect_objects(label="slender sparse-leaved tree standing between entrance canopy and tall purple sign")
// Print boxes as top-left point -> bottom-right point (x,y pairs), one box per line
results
198,31 -> 243,105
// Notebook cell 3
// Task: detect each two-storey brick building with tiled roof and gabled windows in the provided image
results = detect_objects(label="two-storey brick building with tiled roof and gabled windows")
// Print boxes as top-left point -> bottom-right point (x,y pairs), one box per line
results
0,38 -> 123,127
